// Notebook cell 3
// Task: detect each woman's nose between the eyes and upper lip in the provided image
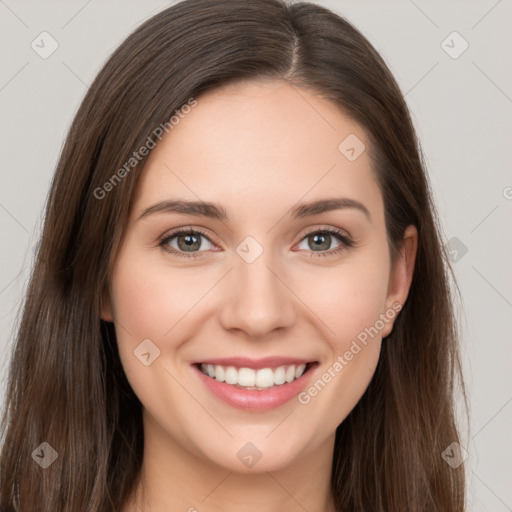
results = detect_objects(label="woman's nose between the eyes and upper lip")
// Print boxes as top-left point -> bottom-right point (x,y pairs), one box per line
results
220,251 -> 296,340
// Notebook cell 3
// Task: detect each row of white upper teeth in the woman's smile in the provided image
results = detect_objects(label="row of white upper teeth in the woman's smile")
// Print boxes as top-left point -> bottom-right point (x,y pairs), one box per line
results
201,364 -> 306,389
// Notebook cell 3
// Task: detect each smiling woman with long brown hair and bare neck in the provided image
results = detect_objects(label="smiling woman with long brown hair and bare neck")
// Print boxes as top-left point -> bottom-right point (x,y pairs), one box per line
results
0,0 -> 465,512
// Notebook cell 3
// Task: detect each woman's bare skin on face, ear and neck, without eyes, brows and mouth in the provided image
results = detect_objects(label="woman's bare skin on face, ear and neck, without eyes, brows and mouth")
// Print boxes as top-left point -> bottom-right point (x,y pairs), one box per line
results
103,81 -> 417,512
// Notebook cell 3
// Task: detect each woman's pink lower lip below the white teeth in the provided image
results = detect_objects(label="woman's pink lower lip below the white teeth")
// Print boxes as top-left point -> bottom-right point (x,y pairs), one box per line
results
193,363 -> 316,411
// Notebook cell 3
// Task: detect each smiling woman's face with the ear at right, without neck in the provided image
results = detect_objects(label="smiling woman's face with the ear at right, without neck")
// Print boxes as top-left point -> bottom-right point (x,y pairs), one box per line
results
103,82 -> 416,472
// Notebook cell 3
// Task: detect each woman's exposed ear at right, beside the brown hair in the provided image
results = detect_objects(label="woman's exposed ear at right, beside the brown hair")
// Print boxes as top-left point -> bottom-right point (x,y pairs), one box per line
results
381,224 -> 418,338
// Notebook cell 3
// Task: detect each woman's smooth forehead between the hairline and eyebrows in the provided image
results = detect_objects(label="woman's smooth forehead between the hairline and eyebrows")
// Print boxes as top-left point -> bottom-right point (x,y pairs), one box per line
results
135,81 -> 382,222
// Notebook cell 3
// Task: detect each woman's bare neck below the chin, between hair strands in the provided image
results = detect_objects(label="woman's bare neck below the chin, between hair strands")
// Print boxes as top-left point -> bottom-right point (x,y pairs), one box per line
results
123,416 -> 336,512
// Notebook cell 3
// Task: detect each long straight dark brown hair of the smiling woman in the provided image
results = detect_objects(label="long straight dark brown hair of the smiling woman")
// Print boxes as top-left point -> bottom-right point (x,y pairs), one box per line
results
0,0 -> 465,512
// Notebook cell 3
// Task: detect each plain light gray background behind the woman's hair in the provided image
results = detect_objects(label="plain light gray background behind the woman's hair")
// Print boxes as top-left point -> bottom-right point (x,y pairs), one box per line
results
0,0 -> 512,512
